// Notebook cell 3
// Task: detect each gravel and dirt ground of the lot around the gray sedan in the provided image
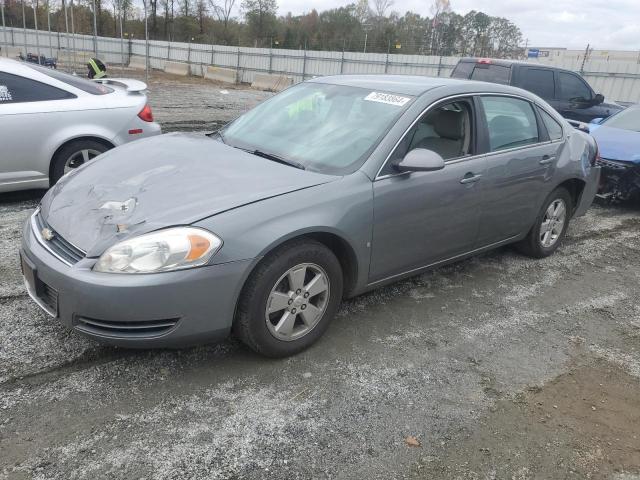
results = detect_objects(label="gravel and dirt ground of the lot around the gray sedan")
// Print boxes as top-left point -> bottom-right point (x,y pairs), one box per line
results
0,72 -> 640,480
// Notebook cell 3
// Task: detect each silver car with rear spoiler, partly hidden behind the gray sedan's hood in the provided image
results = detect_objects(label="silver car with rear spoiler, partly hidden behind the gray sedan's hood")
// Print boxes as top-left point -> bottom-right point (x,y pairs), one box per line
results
0,58 -> 161,192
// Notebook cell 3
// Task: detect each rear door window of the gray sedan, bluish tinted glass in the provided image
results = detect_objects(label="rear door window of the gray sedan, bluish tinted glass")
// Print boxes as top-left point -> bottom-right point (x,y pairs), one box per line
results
480,96 -> 538,152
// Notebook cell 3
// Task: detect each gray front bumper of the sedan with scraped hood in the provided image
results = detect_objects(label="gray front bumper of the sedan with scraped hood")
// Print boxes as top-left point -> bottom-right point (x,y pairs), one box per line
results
20,221 -> 252,348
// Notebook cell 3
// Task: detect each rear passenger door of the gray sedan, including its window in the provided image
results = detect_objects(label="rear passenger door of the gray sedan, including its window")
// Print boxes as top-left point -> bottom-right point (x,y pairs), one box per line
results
478,95 -> 562,247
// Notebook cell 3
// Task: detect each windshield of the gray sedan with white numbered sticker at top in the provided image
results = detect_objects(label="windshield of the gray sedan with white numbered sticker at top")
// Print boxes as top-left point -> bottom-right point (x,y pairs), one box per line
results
221,82 -> 413,175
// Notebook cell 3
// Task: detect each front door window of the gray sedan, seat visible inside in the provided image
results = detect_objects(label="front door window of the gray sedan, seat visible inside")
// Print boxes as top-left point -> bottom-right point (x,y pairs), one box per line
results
381,100 -> 473,175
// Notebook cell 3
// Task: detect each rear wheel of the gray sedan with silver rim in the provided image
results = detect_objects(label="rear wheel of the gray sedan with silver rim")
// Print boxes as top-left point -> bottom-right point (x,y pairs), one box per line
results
516,187 -> 573,258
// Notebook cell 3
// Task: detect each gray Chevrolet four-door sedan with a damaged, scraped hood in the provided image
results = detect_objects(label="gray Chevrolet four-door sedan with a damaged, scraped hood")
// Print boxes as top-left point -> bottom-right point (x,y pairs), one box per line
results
21,75 -> 600,357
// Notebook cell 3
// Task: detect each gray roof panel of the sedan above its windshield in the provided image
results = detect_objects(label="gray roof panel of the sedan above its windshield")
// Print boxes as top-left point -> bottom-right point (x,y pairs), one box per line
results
309,74 -> 478,96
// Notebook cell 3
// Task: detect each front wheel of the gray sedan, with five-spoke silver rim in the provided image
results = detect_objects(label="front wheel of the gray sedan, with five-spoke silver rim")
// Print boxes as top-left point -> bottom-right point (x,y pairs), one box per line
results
233,240 -> 343,357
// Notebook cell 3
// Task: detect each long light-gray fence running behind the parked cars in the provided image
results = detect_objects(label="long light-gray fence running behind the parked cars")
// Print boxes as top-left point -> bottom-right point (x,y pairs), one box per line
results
0,28 -> 640,103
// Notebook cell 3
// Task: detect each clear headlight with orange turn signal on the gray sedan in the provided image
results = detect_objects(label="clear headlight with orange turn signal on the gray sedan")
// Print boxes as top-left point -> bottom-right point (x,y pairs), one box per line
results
93,227 -> 222,273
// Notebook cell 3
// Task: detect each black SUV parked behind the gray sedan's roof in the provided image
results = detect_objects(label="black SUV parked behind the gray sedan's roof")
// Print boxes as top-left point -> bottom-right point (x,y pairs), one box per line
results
451,58 -> 623,123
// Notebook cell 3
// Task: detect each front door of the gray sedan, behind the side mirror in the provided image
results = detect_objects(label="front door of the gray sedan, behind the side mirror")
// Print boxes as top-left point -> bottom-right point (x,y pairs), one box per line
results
369,100 -> 486,283
